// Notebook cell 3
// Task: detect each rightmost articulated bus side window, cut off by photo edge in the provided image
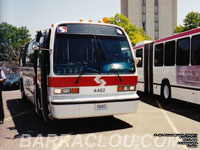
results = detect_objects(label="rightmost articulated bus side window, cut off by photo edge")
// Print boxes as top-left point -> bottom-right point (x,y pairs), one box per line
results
191,35 -> 200,65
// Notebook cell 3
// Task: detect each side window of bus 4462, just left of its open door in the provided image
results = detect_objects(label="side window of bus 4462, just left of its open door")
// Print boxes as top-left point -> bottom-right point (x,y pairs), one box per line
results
25,40 -> 34,67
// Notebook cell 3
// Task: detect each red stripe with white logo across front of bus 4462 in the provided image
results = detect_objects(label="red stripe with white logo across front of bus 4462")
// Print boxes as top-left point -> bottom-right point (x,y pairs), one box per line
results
48,76 -> 138,87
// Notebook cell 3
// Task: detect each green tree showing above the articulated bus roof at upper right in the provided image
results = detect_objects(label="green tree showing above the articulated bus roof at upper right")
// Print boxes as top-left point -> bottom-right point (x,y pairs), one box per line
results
174,11 -> 200,33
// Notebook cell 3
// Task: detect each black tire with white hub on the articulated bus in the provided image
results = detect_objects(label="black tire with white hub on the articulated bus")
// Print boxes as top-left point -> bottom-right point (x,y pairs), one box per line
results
161,80 -> 171,102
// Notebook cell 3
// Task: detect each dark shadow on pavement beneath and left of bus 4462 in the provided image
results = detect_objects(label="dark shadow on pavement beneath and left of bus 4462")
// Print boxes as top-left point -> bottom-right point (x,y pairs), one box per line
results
7,99 -> 133,139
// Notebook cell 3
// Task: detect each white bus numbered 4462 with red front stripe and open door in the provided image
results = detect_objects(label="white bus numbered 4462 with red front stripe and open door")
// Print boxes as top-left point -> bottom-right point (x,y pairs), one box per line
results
20,22 -> 139,121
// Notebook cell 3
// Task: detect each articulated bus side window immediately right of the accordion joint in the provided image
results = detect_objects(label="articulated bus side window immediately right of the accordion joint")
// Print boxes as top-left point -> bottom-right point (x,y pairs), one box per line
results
154,43 -> 164,66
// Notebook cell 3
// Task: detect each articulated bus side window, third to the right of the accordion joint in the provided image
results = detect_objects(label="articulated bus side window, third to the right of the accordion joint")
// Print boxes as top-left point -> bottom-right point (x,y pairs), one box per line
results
176,38 -> 190,66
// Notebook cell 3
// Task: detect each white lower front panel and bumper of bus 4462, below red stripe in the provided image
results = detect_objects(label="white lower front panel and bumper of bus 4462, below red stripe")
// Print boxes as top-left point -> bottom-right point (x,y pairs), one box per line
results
49,86 -> 139,119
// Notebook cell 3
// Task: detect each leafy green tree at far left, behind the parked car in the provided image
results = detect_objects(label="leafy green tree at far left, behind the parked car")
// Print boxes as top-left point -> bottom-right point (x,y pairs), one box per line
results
0,22 -> 31,64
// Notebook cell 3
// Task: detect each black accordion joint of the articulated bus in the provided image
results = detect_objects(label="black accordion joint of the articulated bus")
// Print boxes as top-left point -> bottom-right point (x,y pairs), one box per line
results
144,42 -> 153,94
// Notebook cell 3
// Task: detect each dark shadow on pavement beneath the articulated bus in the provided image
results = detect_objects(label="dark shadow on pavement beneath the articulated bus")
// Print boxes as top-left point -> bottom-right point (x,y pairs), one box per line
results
138,92 -> 200,122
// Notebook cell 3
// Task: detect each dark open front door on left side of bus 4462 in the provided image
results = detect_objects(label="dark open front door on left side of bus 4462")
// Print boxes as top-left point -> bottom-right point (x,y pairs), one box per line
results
34,30 -> 51,120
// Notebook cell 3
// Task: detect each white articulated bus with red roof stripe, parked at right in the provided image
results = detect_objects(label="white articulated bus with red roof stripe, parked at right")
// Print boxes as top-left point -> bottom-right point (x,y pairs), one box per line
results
134,28 -> 200,104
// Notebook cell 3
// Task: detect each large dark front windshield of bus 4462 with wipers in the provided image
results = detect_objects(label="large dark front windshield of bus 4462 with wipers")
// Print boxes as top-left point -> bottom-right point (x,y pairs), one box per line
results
54,34 -> 135,75
